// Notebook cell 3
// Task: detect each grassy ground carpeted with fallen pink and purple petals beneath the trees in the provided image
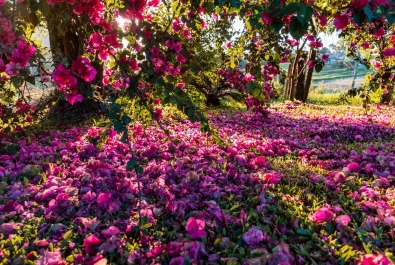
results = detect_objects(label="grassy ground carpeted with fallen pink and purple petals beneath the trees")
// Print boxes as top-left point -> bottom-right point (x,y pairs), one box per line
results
0,104 -> 395,265
